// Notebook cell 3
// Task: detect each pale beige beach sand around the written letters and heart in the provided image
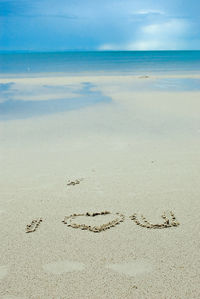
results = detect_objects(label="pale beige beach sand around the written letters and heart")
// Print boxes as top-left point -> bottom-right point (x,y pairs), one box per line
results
0,76 -> 200,299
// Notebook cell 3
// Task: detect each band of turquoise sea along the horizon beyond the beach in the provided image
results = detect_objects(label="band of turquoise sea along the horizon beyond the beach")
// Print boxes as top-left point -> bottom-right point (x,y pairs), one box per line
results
0,51 -> 200,75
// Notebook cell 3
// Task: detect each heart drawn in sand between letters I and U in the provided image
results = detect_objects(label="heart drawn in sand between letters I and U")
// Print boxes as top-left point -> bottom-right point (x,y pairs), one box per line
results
62,211 -> 125,233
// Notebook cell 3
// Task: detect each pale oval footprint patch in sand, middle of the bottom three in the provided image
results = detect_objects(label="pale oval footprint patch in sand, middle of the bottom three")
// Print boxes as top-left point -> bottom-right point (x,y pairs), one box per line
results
43,260 -> 85,274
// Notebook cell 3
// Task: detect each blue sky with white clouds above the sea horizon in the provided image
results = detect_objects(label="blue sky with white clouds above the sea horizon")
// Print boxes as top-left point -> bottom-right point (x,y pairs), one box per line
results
0,0 -> 200,51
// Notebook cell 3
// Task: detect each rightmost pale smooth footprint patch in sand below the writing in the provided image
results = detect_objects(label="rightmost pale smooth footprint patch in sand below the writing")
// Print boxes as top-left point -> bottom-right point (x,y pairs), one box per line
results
106,260 -> 153,276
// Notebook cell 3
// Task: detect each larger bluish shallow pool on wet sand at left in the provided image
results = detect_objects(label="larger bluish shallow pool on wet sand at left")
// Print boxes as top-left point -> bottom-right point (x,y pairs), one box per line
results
0,82 -> 111,120
